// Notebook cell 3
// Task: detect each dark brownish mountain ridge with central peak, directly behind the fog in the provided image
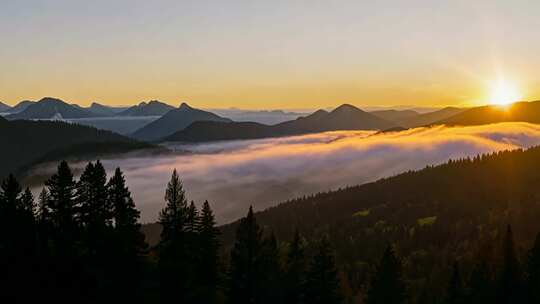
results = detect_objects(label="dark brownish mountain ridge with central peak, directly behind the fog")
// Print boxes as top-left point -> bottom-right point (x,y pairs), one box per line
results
161,104 -> 396,142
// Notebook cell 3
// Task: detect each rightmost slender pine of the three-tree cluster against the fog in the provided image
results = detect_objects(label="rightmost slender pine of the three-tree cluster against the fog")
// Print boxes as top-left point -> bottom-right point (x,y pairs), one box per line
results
197,201 -> 220,303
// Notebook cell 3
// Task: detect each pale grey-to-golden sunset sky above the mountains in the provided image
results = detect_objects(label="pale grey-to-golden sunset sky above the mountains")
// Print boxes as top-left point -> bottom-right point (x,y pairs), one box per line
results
0,0 -> 540,109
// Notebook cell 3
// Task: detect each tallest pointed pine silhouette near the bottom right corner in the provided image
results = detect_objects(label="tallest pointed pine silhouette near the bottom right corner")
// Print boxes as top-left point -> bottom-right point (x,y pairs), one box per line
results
497,225 -> 522,304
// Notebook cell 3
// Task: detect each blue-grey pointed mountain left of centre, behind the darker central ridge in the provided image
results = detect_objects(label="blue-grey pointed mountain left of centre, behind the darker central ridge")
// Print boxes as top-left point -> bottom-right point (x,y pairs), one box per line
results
132,103 -> 232,141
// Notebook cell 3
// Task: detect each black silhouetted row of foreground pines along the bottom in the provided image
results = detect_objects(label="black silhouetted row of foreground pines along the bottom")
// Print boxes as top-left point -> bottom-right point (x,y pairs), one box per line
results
0,161 -> 540,304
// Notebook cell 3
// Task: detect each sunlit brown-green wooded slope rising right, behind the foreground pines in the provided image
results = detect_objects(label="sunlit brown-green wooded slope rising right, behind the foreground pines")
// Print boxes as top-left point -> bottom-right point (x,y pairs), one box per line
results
217,147 -> 540,303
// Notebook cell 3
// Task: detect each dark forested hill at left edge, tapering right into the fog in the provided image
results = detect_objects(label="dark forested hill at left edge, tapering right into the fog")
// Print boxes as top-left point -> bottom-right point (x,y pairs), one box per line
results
0,118 -> 155,178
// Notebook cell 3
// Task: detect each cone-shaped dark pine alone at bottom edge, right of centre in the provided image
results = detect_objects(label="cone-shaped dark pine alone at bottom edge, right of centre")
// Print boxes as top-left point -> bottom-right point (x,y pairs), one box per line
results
366,246 -> 407,304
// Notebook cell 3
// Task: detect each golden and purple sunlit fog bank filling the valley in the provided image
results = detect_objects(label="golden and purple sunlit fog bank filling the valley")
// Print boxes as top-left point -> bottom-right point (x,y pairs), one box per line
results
28,123 -> 540,224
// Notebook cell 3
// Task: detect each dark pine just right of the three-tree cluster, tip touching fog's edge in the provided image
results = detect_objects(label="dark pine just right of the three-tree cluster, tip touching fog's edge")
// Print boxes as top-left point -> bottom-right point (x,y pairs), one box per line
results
229,206 -> 265,304
